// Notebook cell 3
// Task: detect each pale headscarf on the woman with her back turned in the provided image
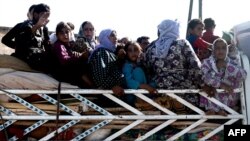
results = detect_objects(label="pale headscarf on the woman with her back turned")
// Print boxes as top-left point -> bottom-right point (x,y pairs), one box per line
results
155,20 -> 180,58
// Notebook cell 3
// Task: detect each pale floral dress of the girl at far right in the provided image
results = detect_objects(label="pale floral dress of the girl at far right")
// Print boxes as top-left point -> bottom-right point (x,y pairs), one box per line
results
200,56 -> 247,112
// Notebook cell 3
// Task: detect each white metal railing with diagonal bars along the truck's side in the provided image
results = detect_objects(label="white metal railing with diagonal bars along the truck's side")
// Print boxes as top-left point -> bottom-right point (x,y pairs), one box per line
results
0,89 -> 247,141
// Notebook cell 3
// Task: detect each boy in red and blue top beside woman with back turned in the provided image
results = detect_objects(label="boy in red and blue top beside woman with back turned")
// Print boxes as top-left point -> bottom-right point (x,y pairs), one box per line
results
187,19 -> 211,61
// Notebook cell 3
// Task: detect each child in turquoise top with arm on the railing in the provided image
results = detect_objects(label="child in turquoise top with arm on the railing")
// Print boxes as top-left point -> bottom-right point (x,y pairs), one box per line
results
122,42 -> 157,94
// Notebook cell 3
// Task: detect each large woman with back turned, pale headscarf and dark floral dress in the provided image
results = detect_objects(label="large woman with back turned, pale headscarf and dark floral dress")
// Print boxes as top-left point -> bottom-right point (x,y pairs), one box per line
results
144,20 -> 201,112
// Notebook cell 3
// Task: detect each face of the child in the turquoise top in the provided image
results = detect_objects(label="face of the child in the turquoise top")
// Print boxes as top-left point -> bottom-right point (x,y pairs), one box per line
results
127,44 -> 141,62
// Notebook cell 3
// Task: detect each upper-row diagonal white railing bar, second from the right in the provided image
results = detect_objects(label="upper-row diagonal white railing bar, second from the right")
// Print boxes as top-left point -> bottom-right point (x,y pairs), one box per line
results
166,93 -> 205,115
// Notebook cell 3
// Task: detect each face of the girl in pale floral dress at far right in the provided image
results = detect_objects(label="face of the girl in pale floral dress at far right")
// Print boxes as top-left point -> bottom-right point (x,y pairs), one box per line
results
214,41 -> 227,60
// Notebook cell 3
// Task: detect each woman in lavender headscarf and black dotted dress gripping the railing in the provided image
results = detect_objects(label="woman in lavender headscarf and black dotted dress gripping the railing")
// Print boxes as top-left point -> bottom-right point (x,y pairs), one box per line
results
89,29 -> 124,95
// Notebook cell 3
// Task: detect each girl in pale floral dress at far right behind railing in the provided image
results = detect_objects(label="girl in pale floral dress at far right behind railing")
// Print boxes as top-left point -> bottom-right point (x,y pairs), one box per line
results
200,38 -> 247,115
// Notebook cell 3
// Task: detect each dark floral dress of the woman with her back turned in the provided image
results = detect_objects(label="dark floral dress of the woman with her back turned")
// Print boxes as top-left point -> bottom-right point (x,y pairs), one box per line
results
144,39 -> 202,112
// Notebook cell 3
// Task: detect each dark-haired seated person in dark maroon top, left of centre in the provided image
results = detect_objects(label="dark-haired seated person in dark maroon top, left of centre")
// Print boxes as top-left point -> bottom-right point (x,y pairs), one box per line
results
52,22 -> 92,87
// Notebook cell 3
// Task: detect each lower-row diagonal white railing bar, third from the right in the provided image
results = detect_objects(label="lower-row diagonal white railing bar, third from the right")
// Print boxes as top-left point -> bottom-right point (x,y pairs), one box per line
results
136,120 -> 176,141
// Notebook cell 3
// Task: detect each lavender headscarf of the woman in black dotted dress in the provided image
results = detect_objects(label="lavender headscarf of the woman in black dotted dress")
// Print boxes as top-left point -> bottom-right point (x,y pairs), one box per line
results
96,29 -> 116,52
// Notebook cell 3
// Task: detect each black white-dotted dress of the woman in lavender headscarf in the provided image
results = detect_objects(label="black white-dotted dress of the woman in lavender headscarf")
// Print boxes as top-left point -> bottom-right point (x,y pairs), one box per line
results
89,48 -> 124,89
